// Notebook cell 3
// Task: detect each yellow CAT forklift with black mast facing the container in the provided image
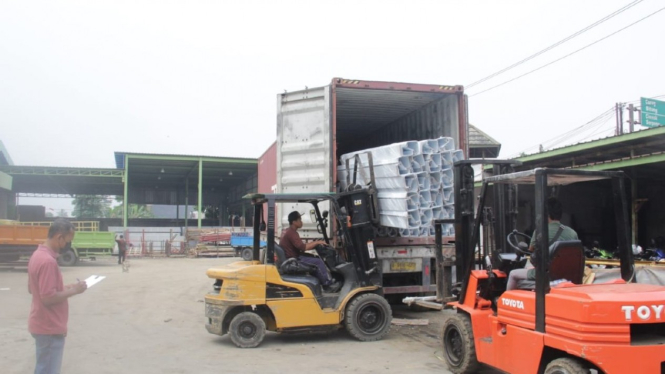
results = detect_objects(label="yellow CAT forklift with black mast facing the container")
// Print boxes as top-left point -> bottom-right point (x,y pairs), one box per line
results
205,189 -> 392,348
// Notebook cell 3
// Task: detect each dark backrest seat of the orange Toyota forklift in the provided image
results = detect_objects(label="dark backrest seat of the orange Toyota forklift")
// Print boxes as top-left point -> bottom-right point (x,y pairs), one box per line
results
517,240 -> 585,290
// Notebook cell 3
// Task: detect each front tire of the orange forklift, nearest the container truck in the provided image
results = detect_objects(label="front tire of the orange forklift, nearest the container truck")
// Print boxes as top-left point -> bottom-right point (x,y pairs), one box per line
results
443,313 -> 480,374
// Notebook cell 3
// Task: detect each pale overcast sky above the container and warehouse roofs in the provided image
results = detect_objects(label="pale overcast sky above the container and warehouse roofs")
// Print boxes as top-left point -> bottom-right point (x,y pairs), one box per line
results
0,0 -> 665,210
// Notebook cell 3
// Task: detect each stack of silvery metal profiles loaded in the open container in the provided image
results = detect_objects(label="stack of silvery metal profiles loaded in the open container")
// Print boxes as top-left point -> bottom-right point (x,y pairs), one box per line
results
337,137 -> 464,237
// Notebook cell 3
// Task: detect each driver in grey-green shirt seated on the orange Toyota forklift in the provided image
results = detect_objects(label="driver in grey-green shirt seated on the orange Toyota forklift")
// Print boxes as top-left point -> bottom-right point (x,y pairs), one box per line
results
506,197 -> 578,291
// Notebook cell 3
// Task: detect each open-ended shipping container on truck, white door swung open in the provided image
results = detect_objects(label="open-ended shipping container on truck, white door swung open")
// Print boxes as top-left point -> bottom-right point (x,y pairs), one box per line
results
270,78 -> 468,294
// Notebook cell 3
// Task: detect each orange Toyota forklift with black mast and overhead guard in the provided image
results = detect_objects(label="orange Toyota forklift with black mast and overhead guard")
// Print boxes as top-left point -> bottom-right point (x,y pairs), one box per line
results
437,160 -> 665,374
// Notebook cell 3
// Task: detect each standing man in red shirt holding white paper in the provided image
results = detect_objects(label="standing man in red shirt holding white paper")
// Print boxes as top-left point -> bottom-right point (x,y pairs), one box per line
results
28,218 -> 87,374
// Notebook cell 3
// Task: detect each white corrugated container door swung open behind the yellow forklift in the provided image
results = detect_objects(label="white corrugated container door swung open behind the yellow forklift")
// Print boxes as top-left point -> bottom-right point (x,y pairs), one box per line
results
275,86 -> 333,238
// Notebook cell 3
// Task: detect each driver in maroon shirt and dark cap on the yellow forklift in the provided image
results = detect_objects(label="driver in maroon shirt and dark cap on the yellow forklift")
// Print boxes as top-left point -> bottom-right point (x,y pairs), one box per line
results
279,211 -> 341,292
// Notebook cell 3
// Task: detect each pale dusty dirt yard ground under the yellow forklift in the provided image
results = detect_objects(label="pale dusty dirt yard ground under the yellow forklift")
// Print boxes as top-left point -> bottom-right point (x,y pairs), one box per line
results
0,258 -> 492,374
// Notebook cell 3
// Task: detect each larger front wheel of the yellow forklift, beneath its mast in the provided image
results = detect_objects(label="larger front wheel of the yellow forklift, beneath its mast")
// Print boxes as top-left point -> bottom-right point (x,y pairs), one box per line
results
344,293 -> 392,342
